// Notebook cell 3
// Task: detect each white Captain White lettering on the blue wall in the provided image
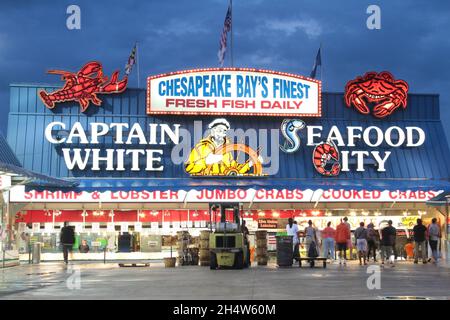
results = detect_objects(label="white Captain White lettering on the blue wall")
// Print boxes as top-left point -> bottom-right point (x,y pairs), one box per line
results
45,122 -> 180,171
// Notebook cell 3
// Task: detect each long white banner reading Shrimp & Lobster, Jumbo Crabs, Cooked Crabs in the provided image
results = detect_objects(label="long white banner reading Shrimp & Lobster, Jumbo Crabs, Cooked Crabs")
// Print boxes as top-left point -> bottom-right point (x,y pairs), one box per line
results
11,186 -> 442,203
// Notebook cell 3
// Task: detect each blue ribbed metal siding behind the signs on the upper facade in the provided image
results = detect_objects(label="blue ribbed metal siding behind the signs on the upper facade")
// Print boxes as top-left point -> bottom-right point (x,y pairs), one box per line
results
8,85 -> 450,179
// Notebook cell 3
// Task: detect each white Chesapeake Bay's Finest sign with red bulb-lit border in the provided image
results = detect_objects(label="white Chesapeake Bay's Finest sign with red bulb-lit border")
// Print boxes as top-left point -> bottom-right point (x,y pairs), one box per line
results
147,68 -> 321,117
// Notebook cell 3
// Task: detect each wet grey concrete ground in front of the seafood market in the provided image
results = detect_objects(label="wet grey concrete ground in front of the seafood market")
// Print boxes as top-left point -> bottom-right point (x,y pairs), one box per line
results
0,262 -> 450,300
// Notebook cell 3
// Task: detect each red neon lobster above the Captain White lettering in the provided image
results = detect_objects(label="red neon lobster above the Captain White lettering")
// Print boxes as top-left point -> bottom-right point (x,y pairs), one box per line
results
38,61 -> 128,112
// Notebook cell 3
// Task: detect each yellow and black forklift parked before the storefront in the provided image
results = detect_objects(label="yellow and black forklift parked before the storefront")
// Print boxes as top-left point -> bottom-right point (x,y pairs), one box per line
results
209,203 -> 250,270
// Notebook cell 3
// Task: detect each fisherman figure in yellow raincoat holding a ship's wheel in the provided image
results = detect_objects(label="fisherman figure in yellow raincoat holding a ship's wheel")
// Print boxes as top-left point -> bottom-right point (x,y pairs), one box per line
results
185,118 -> 263,176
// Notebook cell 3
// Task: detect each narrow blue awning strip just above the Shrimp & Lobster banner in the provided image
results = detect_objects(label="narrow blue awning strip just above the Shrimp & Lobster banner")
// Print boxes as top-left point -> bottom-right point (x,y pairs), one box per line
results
26,177 -> 450,192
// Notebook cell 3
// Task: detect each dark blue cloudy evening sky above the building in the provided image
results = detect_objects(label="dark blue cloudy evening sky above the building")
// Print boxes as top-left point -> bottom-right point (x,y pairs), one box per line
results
0,0 -> 450,138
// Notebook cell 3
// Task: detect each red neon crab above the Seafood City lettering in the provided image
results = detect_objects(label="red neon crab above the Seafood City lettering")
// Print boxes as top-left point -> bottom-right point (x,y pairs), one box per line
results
345,71 -> 409,118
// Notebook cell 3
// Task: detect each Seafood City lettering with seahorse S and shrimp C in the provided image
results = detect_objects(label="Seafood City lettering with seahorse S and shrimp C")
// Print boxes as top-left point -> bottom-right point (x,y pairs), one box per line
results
280,119 -> 426,176
